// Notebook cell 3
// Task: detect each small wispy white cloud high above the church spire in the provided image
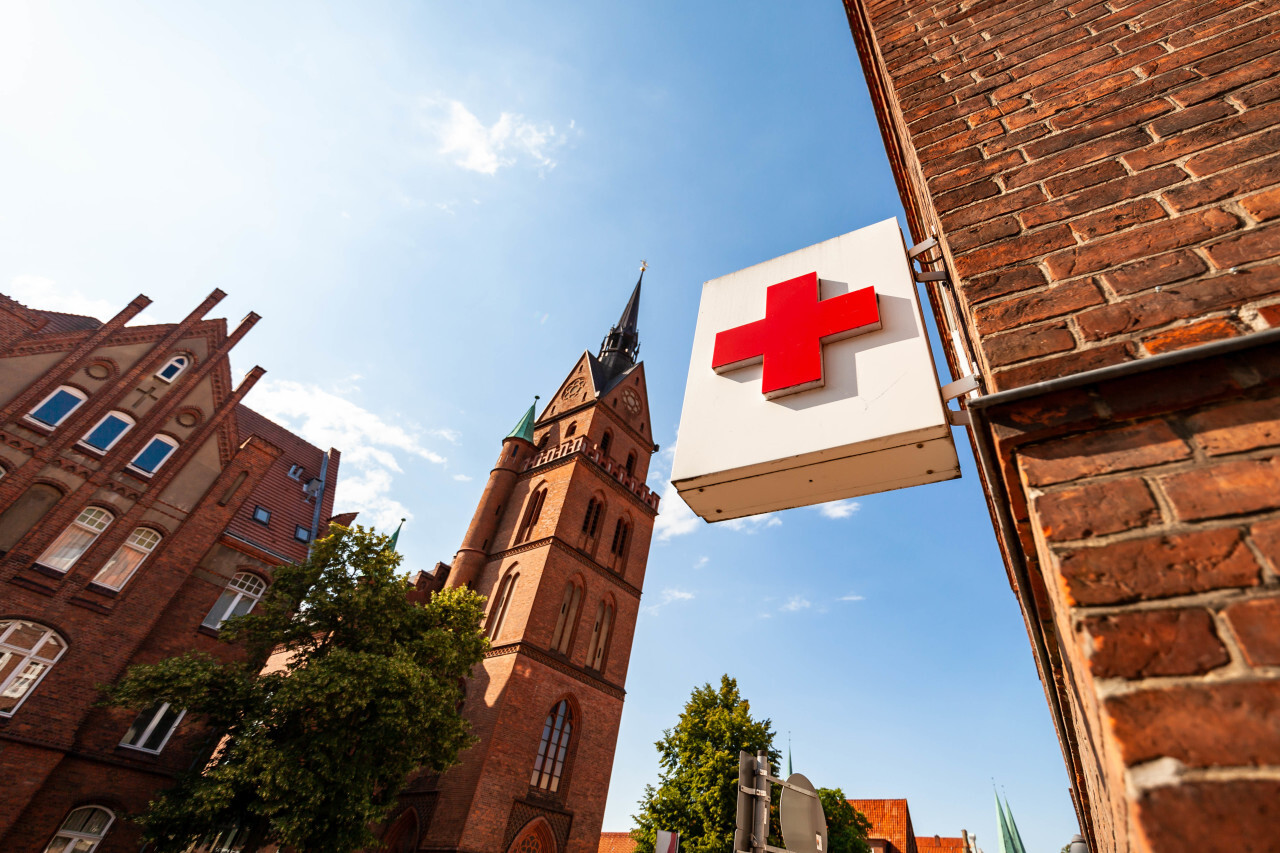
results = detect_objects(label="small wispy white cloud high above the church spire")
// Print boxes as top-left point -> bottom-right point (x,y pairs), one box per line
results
422,99 -> 576,174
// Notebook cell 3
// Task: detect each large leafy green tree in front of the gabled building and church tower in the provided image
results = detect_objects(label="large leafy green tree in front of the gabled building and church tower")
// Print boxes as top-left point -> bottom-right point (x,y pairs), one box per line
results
99,525 -> 488,853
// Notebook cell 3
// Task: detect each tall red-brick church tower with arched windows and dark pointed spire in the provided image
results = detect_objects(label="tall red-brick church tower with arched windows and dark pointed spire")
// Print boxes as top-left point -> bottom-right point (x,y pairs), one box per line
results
399,269 -> 658,853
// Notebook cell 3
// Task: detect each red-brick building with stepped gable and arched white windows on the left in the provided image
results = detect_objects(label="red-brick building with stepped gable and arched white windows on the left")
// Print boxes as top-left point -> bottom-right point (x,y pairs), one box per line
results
0,291 -> 339,853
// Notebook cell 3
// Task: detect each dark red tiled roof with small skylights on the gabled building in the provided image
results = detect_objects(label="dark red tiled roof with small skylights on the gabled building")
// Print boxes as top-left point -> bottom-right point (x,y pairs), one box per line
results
227,405 -> 339,562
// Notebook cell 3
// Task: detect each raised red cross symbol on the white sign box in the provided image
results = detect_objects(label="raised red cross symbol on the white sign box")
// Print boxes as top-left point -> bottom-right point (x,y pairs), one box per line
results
712,273 -> 881,400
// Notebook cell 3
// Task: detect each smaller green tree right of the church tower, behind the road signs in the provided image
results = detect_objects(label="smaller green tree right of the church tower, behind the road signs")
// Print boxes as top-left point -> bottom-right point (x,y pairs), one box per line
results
632,675 -> 780,853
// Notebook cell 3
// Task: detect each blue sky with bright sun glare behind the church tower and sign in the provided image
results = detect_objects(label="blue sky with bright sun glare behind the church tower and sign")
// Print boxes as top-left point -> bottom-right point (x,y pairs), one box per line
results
0,0 -> 1075,853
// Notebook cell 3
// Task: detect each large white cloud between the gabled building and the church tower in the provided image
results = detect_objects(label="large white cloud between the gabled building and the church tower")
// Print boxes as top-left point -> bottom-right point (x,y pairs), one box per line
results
247,380 -> 457,529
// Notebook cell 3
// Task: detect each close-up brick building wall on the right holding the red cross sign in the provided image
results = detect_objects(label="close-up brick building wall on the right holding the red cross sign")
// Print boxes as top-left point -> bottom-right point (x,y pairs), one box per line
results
845,0 -> 1280,853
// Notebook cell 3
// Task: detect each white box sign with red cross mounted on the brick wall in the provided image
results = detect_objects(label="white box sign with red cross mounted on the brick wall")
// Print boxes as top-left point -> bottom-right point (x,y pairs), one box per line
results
671,219 -> 960,521
